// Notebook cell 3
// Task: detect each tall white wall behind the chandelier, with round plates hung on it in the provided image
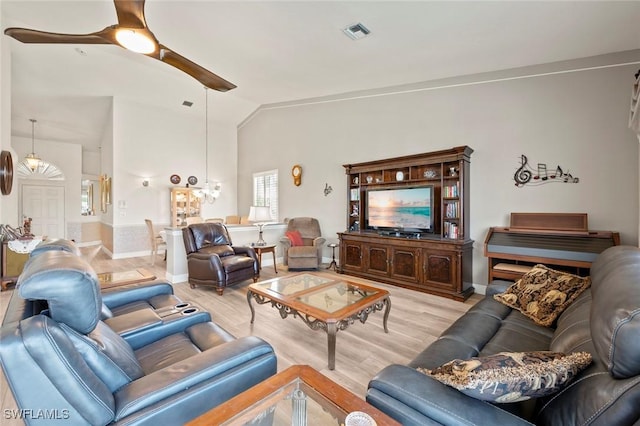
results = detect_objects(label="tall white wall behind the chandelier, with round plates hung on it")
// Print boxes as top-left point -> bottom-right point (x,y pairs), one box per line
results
110,98 -> 237,257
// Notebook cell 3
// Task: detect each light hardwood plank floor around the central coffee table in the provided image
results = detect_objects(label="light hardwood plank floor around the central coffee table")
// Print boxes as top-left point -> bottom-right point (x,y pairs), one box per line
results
0,249 -> 482,426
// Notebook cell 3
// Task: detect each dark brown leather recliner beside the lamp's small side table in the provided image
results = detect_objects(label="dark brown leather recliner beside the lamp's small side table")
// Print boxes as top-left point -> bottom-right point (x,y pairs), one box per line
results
182,222 -> 260,295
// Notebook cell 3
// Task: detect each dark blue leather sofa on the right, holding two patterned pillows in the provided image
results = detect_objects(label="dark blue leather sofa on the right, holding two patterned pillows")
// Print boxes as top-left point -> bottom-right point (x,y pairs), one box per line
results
367,246 -> 640,426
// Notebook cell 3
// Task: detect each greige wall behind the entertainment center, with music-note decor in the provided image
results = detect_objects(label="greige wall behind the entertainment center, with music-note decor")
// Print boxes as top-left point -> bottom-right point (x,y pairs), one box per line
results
238,58 -> 639,285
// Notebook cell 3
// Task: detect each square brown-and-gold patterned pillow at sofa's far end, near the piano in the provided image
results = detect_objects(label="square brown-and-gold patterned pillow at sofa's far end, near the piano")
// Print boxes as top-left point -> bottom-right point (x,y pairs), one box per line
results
493,265 -> 591,327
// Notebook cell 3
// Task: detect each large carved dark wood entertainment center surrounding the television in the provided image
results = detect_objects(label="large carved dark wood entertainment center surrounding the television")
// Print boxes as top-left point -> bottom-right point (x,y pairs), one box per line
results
338,146 -> 473,301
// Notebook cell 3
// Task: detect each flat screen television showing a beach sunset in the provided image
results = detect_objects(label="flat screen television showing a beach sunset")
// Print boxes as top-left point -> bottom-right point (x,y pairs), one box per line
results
365,186 -> 433,232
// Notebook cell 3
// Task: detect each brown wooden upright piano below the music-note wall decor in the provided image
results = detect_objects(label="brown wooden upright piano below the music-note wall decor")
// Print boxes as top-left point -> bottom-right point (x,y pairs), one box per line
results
484,213 -> 620,282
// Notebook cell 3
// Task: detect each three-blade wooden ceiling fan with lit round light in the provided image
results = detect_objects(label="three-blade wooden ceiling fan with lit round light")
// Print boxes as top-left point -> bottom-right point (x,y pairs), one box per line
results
4,0 -> 236,92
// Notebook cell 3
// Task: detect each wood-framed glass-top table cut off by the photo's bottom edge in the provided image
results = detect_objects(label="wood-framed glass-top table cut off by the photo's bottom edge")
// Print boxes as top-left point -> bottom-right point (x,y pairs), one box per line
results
187,365 -> 400,426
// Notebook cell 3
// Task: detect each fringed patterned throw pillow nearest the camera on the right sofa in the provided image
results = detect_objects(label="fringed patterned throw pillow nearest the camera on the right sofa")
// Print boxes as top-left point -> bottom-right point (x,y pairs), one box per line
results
418,351 -> 591,403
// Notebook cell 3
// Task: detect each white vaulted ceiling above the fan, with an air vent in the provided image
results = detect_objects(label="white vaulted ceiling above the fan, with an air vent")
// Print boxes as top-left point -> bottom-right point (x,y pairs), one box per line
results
5,0 -> 640,151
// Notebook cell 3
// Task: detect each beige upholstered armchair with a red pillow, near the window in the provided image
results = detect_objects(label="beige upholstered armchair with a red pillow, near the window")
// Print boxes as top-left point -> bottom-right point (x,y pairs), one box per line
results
280,217 -> 325,270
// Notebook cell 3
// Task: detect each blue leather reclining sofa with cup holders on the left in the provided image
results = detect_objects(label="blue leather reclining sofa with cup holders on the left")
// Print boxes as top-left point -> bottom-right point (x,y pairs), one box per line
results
0,250 -> 277,425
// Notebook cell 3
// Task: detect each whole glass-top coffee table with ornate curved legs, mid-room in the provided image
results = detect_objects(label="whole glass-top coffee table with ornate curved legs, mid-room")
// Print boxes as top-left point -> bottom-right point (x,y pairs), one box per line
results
247,273 -> 391,370
